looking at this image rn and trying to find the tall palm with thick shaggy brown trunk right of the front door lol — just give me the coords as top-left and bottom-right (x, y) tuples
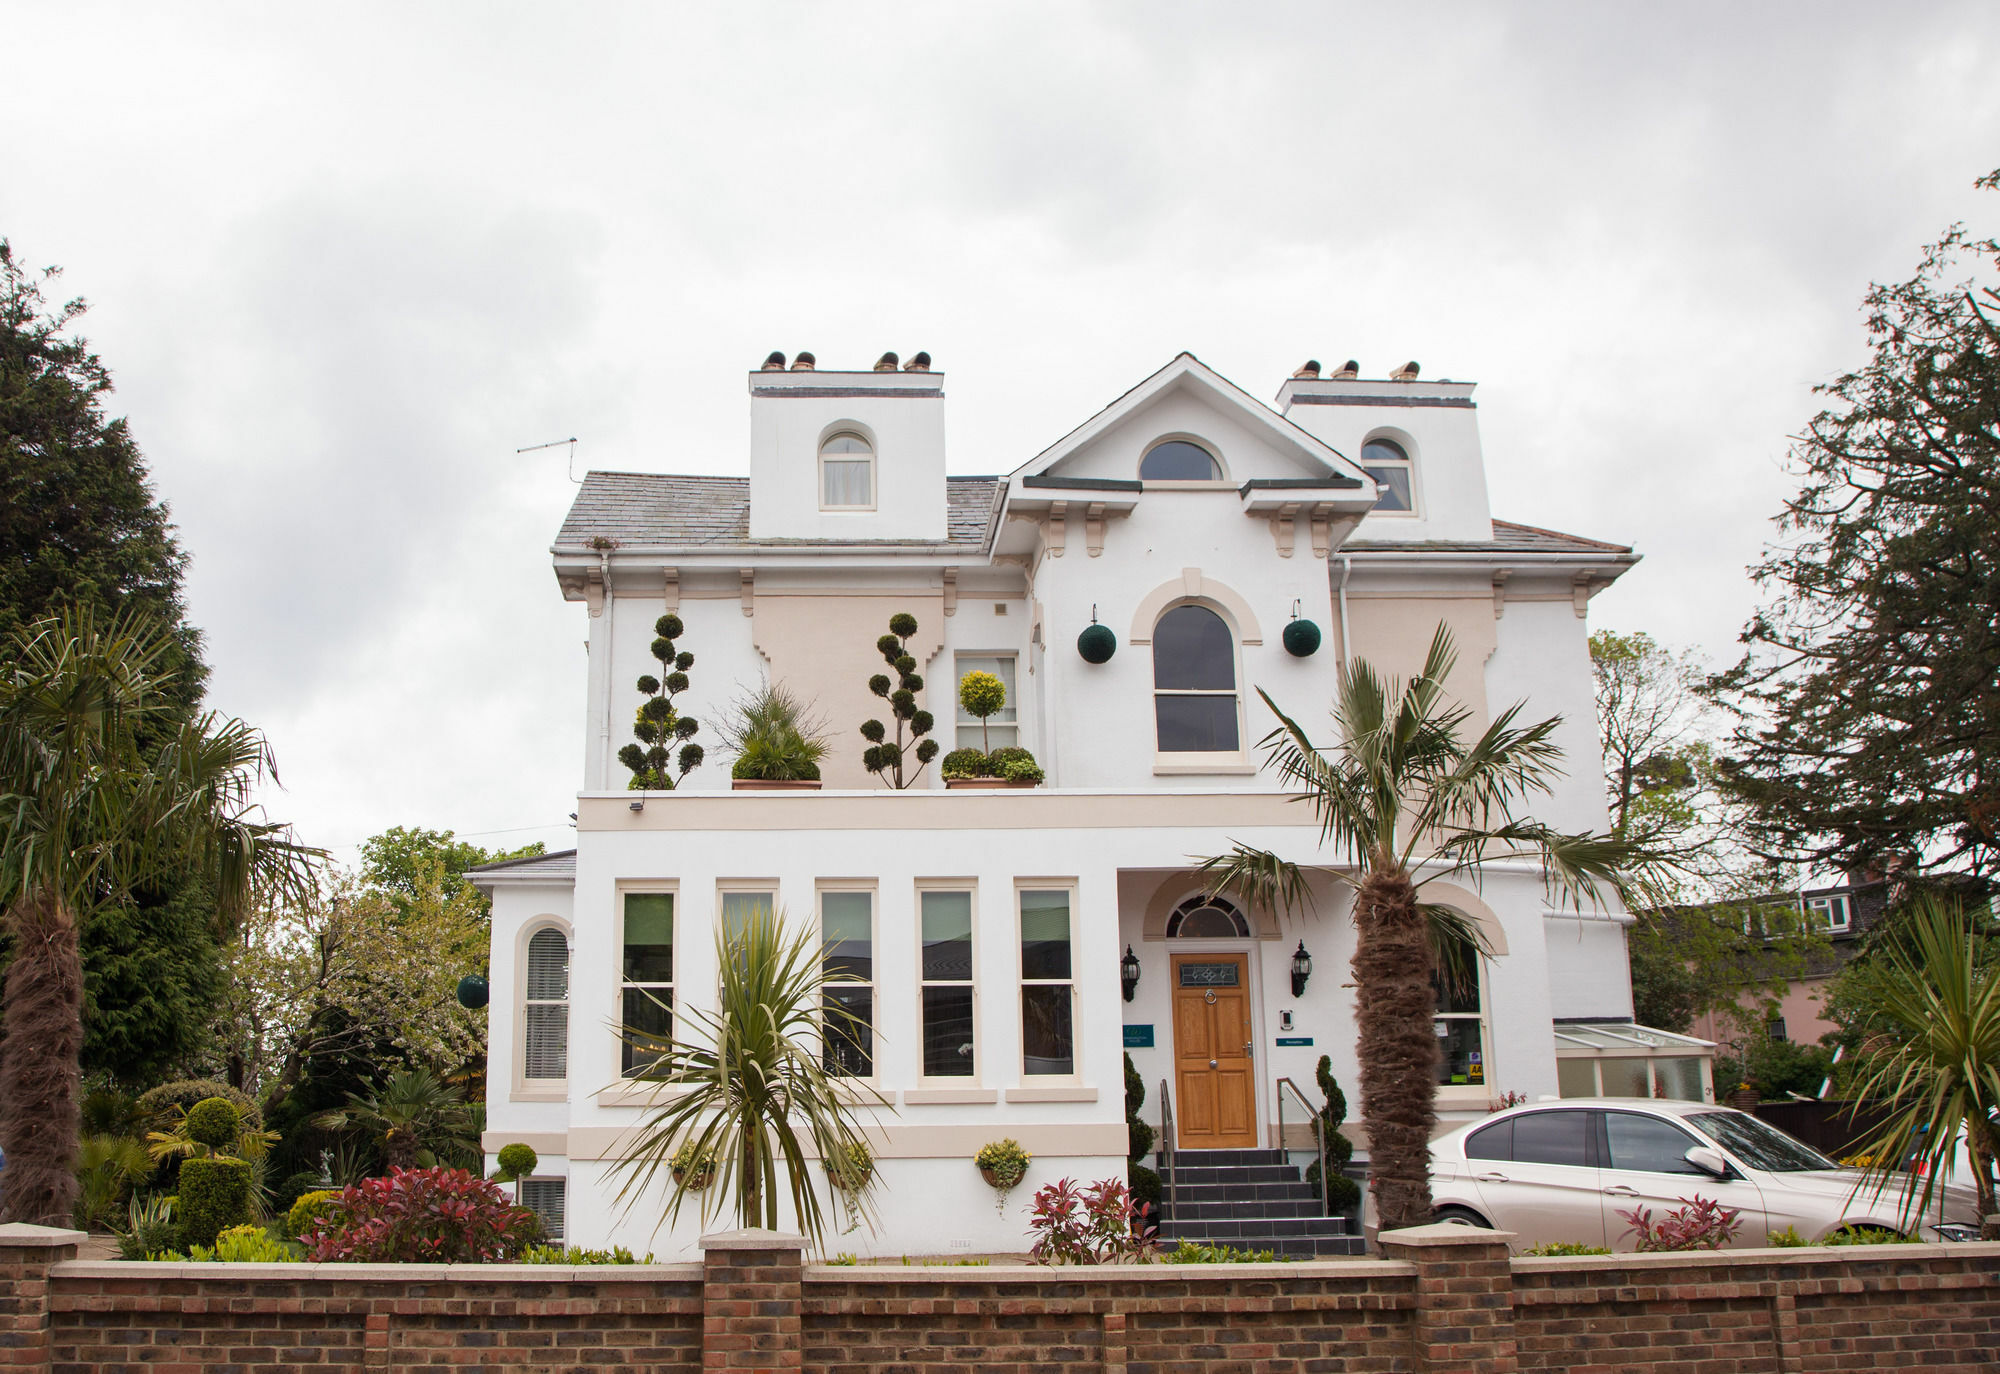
(1204, 624), (1638, 1230)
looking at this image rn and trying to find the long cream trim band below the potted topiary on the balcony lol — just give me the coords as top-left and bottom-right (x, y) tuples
(576, 788), (1318, 834)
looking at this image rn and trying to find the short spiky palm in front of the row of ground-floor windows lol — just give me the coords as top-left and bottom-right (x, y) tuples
(618, 908), (888, 1246)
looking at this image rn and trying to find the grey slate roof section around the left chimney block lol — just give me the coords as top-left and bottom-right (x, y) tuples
(556, 472), (1000, 550)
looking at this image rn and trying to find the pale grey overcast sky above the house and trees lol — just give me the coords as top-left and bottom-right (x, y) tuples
(0, 0), (2000, 854)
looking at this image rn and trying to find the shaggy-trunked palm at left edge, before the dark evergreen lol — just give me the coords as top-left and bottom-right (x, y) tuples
(0, 610), (318, 1226)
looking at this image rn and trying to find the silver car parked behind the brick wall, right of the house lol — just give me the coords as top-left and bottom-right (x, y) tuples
(1430, 1098), (1978, 1250)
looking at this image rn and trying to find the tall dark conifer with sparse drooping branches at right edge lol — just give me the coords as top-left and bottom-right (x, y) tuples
(1716, 172), (2000, 874)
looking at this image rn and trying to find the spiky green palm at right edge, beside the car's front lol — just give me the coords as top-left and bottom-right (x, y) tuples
(1854, 894), (2000, 1240)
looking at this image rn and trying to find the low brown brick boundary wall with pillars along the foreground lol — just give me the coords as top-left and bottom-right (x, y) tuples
(0, 1226), (2000, 1374)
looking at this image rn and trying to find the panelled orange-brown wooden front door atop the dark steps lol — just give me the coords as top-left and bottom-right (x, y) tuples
(1174, 954), (1256, 1150)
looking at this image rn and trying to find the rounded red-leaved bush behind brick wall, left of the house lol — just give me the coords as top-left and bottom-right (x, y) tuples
(300, 1168), (542, 1264)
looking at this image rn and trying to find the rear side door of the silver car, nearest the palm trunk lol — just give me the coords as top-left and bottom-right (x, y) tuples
(1466, 1108), (1604, 1250)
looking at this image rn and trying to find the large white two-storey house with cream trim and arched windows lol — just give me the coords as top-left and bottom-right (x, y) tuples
(476, 354), (1706, 1256)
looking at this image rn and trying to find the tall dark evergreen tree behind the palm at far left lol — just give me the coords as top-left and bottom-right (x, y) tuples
(0, 240), (220, 1086)
